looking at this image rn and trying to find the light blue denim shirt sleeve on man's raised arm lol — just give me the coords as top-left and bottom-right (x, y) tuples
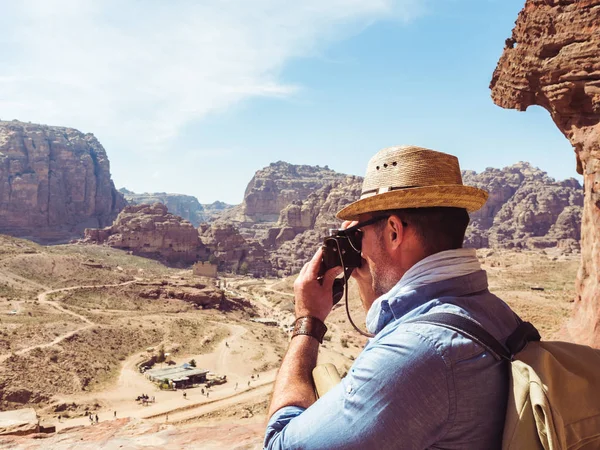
(264, 329), (456, 450)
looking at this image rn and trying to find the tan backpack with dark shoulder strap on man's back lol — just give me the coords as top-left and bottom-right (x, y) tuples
(409, 313), (600, 450)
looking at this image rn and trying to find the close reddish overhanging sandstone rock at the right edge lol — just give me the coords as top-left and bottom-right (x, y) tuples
(491, 0), (600, 347)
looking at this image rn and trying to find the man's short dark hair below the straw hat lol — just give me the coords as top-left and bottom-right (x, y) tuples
(379, 206), (470, 255)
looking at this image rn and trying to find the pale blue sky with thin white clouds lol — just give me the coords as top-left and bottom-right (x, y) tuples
(0, 0), (580, 204)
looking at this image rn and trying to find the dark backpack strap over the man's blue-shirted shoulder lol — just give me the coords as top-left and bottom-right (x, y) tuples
(405, 312), (540, 361)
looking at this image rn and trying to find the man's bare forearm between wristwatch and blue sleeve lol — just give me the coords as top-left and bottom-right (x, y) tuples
(269, 335), (319, 417)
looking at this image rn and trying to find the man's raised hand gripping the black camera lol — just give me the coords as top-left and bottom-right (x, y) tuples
(294, 248), (343, 322)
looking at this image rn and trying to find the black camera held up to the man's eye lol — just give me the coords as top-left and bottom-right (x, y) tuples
(318, 229), (362, 305)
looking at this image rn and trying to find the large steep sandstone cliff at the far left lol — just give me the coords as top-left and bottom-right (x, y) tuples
(0, 121), (125, 242)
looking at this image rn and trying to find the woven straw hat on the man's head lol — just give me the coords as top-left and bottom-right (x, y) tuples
(337, 145), (488, 220)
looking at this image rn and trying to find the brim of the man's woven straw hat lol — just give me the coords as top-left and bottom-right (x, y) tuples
(337, 185), (488, 220)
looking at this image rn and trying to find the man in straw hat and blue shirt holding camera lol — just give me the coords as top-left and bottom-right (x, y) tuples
(264, 146), (518, 449)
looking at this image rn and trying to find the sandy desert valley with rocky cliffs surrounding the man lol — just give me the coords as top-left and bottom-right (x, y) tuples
(0, 0), (600, 449)
